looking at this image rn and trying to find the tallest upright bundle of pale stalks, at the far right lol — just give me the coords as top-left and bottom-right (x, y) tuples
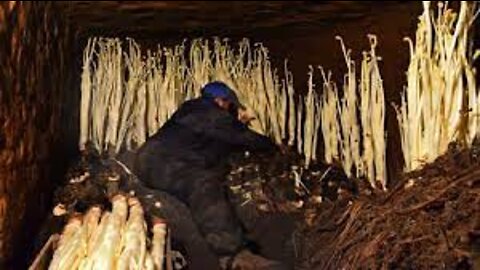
(397, 1), (480, 171)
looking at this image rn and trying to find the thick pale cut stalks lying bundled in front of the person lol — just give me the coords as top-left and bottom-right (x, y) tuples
(49, 195), (166, 270)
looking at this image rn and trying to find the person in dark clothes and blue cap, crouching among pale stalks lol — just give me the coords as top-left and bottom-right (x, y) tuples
(135, 82), (284, 268)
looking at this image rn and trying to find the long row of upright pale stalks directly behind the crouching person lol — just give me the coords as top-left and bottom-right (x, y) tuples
(79, 38), (304, 156)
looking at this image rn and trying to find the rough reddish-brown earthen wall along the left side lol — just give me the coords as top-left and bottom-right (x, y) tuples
(0, 1), (78, 268)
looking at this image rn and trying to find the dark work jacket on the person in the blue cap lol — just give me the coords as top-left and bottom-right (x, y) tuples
(135, 98), (275, 199)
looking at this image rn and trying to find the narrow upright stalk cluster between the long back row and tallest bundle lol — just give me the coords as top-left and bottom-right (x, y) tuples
(319, 35), (387, 189)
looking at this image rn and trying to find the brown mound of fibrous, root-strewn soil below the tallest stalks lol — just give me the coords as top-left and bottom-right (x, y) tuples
(297, 142), (480, 269)
